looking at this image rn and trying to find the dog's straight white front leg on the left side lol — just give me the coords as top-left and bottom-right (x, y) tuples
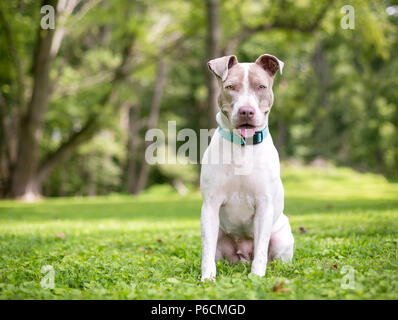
(200, 202), (220, 281)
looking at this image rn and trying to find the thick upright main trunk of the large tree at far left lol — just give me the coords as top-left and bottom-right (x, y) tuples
(7, 0), (79, 200)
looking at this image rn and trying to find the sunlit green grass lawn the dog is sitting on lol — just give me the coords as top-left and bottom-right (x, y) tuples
(0, 167), (398, 299)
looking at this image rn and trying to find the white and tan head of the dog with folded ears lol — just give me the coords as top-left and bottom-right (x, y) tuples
(208, 54), (283, 138)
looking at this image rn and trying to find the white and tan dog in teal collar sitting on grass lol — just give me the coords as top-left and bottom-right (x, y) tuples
(200, 54), (294, 281)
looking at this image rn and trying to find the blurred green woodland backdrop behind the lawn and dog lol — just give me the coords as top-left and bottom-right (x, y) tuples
(0, 0), (398, 199)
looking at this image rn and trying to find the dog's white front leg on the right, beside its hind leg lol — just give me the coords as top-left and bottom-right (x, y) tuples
(251, 195), (274, 277)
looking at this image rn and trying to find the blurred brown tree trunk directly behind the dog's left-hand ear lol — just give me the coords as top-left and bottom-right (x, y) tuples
(205, 0), (220, 129)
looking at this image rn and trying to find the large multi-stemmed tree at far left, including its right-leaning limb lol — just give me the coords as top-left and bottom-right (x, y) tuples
(1, 0), (135, 200)
